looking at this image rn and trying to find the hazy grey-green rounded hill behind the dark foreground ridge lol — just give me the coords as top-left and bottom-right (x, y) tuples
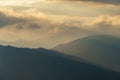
(54, 35), (120, 72)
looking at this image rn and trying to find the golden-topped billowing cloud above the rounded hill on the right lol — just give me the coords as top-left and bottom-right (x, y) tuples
(83, 15), (120, 35)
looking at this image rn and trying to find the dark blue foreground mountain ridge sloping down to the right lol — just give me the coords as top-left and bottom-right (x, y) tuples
(0, 46), (120, 80)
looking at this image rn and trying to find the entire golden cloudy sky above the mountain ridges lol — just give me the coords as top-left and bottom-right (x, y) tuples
(0, 0), (120, 48)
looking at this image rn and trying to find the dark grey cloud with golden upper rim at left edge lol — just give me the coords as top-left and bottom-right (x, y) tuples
(0, 11), (40, 30)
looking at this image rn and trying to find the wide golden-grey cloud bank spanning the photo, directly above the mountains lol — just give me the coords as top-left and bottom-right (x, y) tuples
(0, 8), (120, 48)
